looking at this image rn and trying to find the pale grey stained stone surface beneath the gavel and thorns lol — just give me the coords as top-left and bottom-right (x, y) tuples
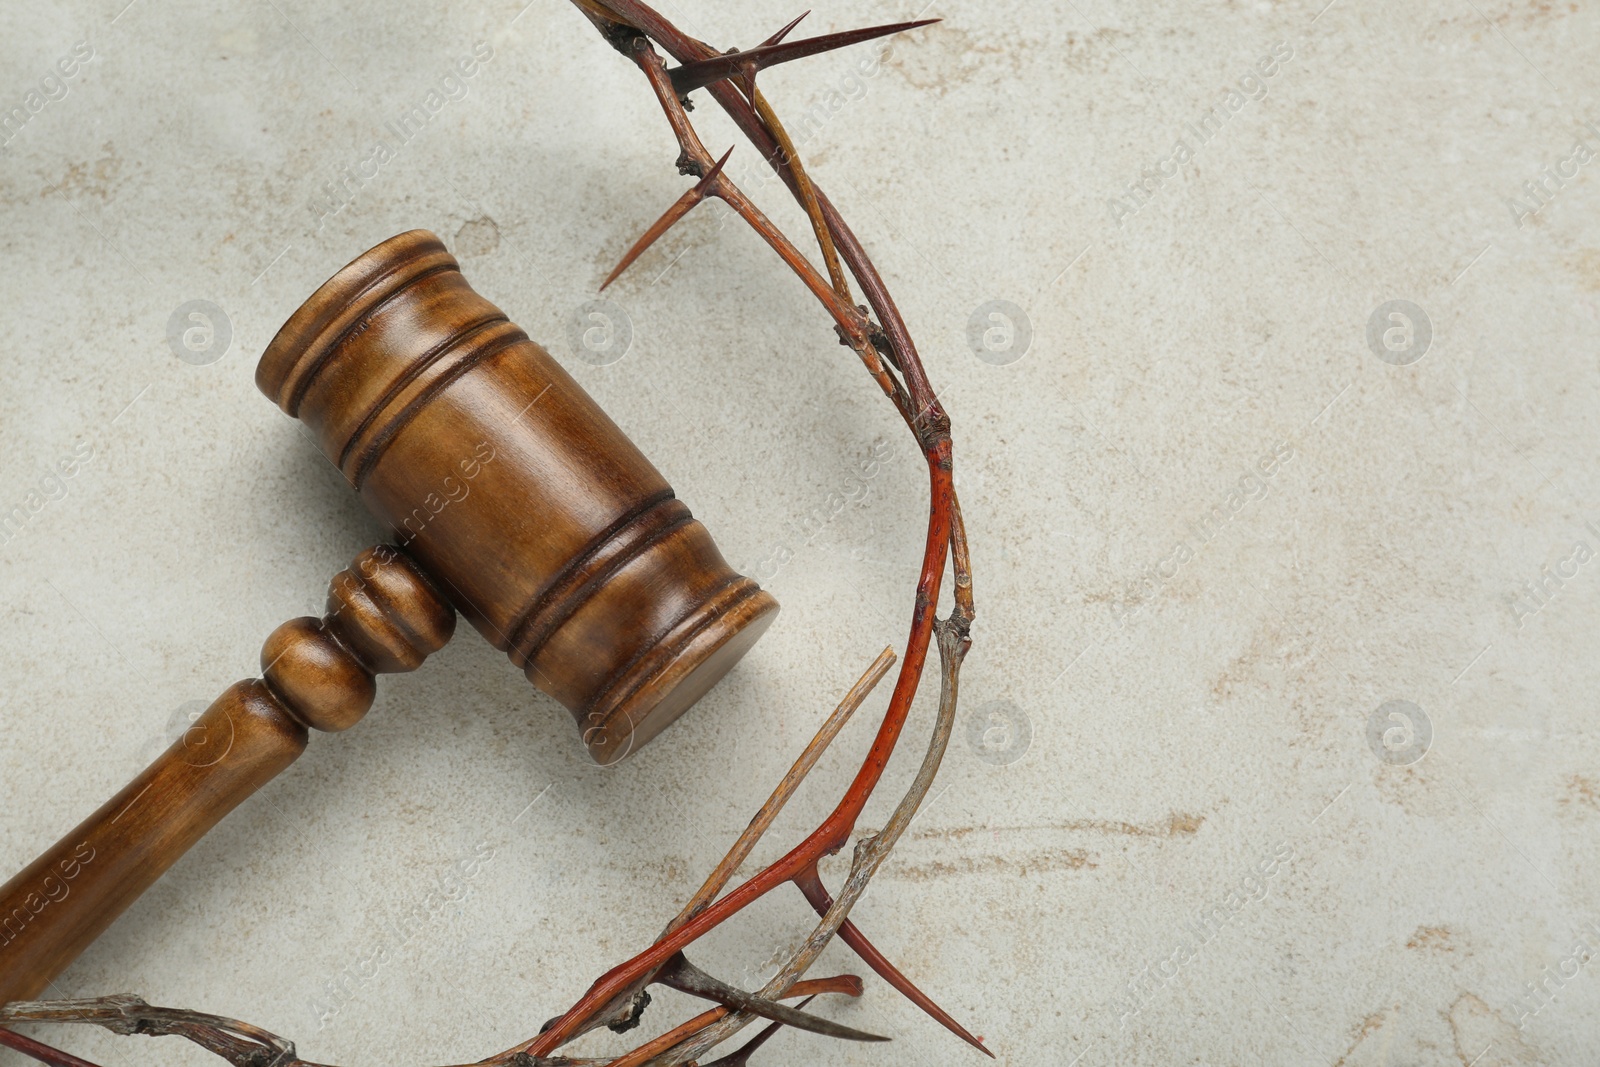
(0, 0), (1600, 1067)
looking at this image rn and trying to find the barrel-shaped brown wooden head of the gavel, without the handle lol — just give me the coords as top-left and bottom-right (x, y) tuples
(256, 230), (778, 763)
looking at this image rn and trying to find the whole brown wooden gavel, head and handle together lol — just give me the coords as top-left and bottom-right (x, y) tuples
(0, 230), (778, 1003)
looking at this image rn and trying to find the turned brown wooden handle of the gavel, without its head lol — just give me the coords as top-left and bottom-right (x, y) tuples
(0, 545), (456, 1005)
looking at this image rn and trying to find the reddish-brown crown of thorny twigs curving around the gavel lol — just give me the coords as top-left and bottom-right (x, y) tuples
(0, 0), (989, 1067)
